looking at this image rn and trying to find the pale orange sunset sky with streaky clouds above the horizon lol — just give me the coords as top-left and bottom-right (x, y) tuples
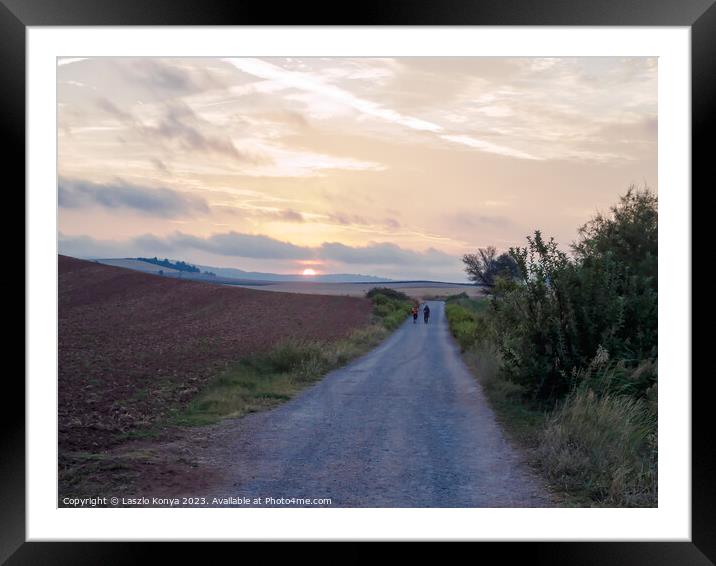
(57, 57), (658, 282)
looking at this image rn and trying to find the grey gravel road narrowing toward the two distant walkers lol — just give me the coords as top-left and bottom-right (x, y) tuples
(199, 301), (551, 507)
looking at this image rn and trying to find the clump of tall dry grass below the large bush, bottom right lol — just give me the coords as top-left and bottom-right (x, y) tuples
(538, 388), (657, 506)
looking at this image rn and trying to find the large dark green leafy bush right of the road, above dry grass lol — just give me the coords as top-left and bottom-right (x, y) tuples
(490, 188), (657, 400)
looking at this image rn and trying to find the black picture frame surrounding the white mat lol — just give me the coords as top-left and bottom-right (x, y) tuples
(7, 0), (704, 565)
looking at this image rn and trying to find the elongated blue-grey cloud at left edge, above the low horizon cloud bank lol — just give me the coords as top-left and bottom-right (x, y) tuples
(58, 178), (209, 218)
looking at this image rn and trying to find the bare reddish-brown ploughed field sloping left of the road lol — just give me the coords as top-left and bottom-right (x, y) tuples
(58, 256), (372, 456)
